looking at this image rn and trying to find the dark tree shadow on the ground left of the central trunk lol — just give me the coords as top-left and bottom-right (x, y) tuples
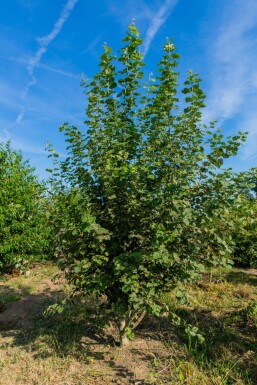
(0, 291), (103, 348)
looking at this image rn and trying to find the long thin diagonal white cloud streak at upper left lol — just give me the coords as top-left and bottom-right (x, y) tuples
(16, 0), (78, 124)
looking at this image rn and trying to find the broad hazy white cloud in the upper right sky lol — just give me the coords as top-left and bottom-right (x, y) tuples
(203, 0), (257, 120)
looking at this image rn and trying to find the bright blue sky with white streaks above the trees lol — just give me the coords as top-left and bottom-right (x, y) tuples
(0, 0), (257, 177)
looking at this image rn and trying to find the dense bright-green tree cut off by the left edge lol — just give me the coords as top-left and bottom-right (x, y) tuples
(0, 142), (49, 271)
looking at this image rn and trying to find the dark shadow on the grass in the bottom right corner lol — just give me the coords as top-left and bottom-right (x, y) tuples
(168, 309), (257, 384)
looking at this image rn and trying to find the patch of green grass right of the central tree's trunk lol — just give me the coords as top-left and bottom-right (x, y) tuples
(158, 269), (257, 385)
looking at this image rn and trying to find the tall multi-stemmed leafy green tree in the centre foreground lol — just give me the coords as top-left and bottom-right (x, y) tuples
(48, 24), (252, 344)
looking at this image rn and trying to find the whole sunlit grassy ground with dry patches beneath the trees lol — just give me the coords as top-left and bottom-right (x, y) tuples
(0, 266), (257, 385)
